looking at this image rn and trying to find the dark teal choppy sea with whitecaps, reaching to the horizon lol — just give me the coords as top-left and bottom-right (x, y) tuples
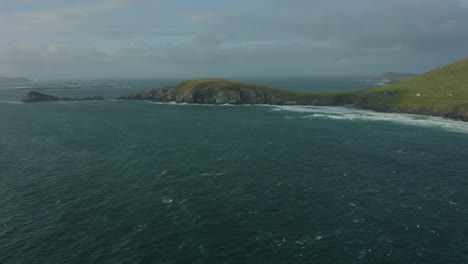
(0, 78), (468, 264)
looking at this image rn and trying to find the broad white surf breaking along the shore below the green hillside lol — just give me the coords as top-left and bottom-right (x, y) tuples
(273, 106), (468, 133)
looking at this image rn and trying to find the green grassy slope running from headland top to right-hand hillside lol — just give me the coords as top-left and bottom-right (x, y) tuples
(175, 58), (468, 112)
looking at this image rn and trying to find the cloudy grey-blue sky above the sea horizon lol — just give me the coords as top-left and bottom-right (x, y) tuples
(0, 0), (468, 80)
